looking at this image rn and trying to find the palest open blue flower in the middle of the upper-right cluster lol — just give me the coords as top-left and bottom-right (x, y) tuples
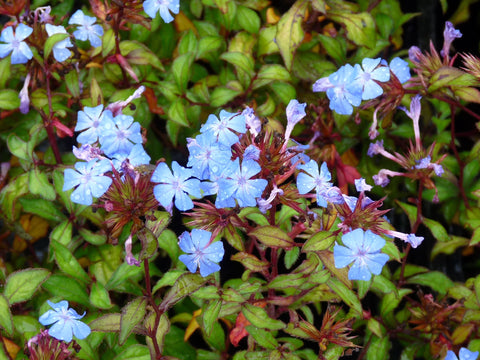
(356, 58), (390, 100)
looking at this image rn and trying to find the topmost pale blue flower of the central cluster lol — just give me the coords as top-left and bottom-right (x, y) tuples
(200, 110), (247, 146)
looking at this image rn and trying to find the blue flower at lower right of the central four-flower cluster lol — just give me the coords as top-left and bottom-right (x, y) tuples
(217, 158), (268, 207)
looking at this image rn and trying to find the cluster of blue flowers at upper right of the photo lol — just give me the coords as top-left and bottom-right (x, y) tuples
(313, 57), (410, 115)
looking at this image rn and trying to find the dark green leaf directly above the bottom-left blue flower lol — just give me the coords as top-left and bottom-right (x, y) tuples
(42, 274), (90, 306)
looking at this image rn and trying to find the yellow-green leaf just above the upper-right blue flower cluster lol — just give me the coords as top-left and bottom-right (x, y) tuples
(328, 12), (377, 48)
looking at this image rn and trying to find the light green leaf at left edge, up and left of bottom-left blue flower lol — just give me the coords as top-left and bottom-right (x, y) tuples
(3, 268), (50, 305)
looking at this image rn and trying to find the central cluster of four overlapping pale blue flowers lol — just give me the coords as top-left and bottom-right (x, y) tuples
(152, 110), (267, 211)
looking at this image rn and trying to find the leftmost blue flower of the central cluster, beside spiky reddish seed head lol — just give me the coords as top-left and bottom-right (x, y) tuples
(151, 161), (202, 211)
